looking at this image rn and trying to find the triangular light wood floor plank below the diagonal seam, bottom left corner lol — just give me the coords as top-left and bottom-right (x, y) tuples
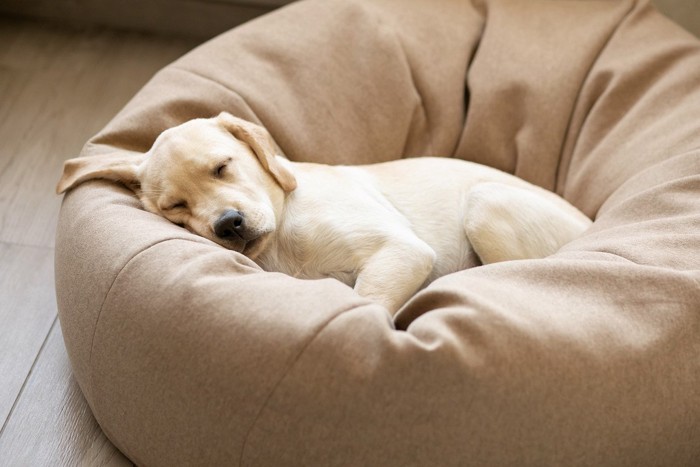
(0, 321), (132, 467)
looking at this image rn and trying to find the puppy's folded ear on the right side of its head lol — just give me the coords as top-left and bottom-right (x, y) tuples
(216, 112), (297, 193)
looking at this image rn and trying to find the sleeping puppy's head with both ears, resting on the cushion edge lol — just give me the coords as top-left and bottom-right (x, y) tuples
(56, 112), (296, 258)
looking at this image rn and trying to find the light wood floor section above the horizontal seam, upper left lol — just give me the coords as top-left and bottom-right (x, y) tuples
(0, 20), (195, 246)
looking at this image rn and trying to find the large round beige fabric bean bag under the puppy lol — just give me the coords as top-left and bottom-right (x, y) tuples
(56, 0), (700, 466)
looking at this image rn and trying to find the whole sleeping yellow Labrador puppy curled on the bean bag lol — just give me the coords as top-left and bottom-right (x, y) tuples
(57, 112), (591, 314)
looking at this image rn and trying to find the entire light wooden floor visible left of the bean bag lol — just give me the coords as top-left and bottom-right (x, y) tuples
(0, 18), (197, 467)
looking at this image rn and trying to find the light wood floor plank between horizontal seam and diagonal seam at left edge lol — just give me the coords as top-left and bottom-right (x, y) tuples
(0, 243), (56, 432)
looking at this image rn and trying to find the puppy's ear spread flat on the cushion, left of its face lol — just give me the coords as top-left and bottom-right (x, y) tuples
(56, 151), (146, 195)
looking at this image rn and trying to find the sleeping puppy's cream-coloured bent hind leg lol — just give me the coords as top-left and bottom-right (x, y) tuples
(464, 182), (591, 264)
